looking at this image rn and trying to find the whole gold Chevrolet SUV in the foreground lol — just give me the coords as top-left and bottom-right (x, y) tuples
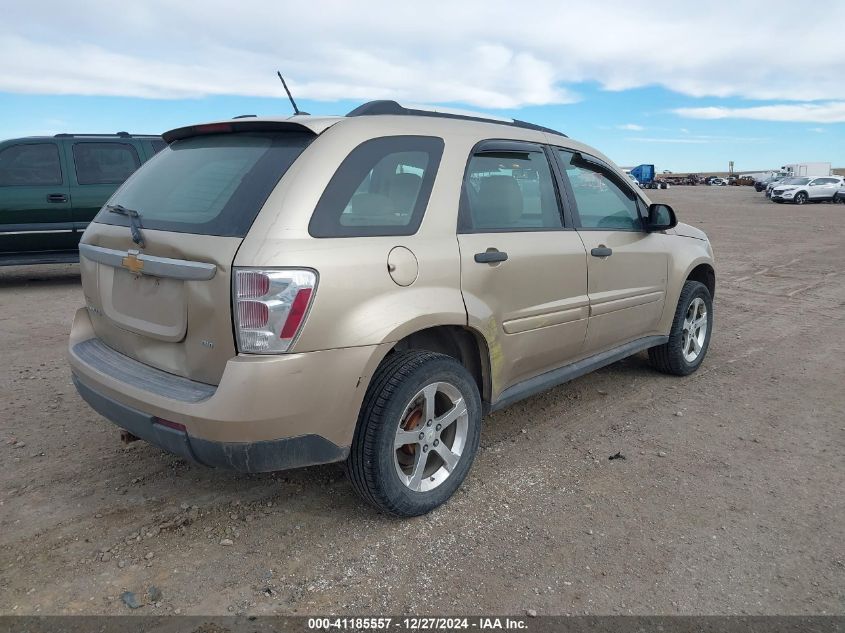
(69, 101), (715, 516)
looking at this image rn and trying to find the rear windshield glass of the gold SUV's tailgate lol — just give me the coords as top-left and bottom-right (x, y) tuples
(95, 133), (314, 237)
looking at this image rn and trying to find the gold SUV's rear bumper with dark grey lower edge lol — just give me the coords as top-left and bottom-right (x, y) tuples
(68, 308), (389, 472)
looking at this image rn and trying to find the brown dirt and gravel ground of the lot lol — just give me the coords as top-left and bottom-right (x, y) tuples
(0, 187), (845, 615)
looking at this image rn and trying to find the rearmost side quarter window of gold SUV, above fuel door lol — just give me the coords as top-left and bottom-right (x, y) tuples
(308, 136), (443, 237)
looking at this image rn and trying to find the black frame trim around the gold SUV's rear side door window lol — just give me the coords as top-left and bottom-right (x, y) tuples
(456, 138), (575, 235)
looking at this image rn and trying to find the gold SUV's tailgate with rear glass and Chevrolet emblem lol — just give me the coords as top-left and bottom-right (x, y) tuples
(80, 132), (313, 384)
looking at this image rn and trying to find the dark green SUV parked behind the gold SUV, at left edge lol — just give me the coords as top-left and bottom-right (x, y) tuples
(0, 132), (166, 266)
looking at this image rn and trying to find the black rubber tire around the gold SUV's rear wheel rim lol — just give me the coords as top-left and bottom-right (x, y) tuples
(346, 350), (481, 517)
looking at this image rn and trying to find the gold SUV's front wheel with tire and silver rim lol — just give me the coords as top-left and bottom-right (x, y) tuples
(648, 281), (713, 376)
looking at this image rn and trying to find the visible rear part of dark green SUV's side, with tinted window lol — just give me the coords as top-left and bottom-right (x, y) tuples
(65, 138), (141, 233)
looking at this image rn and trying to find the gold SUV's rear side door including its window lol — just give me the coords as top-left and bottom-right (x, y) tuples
(458, 141), (588, 400)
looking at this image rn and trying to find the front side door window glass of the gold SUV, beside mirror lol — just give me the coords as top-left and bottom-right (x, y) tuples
(558, 150), (642, 231)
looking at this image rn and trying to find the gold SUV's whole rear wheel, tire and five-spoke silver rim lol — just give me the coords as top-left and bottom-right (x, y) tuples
(346, 350), (481, 517)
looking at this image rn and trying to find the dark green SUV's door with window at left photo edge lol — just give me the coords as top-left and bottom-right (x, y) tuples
(0, 139), (75, 255)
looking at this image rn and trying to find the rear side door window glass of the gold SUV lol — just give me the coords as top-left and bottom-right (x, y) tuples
(462, 148), (563, 231)
